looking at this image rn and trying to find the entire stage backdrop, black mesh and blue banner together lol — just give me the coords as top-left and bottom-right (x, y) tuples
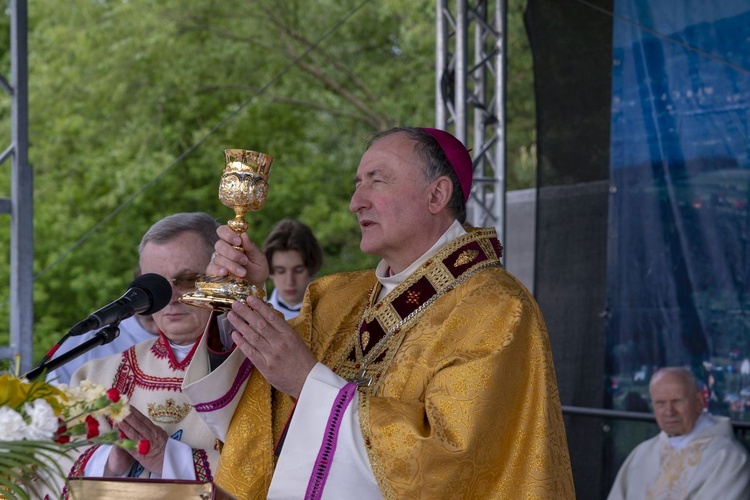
(526, 0), (750, 499)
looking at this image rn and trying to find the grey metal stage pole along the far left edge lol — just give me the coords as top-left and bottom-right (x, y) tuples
(0, 0), (34, 373)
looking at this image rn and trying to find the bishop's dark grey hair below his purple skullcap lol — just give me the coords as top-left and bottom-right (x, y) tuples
(367, 127), (466, 224)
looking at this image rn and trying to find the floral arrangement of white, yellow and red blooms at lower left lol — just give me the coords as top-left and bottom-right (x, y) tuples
(0, 374), (149, 499)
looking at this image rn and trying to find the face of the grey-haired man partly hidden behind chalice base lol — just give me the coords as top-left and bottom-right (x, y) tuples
(140, 232), (211, 345)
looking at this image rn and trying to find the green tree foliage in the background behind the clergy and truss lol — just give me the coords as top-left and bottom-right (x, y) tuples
(0, 0), (534, 356)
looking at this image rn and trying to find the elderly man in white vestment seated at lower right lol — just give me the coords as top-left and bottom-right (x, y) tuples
(608, 367), (750, 500)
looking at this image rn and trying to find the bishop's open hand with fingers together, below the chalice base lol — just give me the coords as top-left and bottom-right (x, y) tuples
(227, 296), (318, 399)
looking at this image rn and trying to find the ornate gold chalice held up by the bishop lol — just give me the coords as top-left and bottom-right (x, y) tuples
(179, 149), (273, 311)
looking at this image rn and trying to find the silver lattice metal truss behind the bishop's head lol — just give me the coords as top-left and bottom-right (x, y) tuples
(435, 0), (507, 246)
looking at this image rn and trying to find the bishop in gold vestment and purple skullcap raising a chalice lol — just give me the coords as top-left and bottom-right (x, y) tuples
(183, 128), (575, 500)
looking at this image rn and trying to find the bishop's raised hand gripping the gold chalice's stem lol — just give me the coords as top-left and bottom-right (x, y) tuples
(206, 226), (268, 289)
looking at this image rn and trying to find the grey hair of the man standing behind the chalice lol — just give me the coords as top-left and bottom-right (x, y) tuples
(138, 212), (219, 261)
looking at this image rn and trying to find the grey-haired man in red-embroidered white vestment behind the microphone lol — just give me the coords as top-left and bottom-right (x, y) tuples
(70, 213), (218, 481)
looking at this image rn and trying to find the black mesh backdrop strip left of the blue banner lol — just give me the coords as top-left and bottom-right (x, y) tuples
(526, 0), (612, 499)
